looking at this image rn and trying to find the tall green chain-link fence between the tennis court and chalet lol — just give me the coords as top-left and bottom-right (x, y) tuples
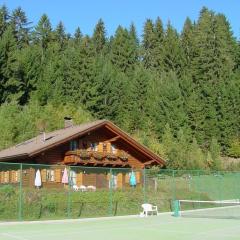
(0, 163), (240, 221)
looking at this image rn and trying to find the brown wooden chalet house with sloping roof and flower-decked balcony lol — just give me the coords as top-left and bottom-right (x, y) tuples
(0, 119), (165, 188)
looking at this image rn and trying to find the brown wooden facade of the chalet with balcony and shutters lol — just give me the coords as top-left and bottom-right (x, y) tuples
(0, 121), (164, 189)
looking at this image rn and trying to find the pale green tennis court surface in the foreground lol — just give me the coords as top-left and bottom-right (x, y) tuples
(0, 214), (240, 240)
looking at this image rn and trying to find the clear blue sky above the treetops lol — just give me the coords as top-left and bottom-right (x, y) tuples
(0, 0), (240, 38)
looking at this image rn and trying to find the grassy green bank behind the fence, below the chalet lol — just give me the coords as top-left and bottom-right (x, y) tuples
(0, 185), (208, 221)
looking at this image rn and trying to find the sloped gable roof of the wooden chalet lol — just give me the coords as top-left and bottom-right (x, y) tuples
(0, 120), (165, 165)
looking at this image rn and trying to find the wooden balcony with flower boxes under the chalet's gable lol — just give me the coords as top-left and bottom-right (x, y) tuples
(64, 149), (129, 167)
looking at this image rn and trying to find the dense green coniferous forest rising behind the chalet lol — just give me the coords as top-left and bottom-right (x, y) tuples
(0, 6), (240, 170)
